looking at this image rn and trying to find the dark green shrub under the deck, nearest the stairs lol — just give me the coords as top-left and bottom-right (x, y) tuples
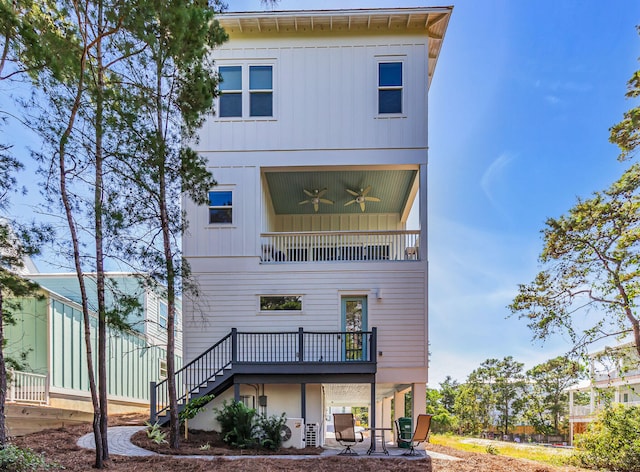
(215, 401), (258, 449)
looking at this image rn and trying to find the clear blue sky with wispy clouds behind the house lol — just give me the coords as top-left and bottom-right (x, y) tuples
(6, 0), (640, 387)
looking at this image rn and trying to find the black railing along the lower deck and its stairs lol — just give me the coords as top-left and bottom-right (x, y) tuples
(150, 328), (377, 421)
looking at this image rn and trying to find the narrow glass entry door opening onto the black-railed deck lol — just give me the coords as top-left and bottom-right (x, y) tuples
(342, 297), (367, 361)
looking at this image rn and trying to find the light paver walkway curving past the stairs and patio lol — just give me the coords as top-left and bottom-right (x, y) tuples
(78, 426), (460, 461)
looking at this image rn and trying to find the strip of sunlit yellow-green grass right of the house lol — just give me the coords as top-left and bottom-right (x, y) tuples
(429, 434), (571, 466)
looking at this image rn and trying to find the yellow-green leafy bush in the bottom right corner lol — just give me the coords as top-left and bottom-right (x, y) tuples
(572, 404), (640, 472)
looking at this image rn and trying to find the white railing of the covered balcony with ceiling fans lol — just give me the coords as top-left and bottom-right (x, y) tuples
(260, 230), (420, 263)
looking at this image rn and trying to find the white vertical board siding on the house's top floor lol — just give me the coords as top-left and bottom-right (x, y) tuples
(197, 39), (428, 153)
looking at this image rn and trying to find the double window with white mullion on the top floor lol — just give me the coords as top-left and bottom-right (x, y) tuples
(218, 64), (273, 118)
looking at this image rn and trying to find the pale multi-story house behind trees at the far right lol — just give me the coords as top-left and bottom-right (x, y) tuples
(569, 343), (640, 444)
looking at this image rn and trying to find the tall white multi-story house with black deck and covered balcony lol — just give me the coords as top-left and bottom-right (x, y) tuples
(152, 7), (452, 444)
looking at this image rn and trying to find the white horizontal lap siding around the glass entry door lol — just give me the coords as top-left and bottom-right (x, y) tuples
(185, 264), (427, 382)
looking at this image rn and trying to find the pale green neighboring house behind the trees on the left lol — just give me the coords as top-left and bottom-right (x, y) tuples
(5, 273), (182, 434)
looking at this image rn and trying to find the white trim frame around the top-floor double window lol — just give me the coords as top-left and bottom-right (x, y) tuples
(214, 59), (278, 121)
